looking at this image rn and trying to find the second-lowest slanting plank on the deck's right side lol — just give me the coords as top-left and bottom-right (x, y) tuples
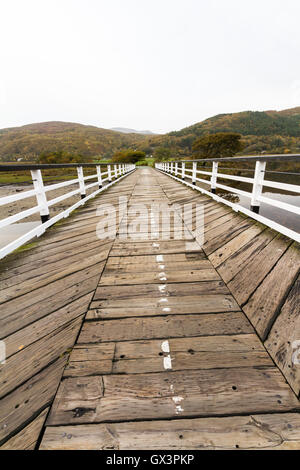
(243, 243), (300, 340)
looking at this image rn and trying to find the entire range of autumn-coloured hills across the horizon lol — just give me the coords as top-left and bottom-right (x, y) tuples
(0, 107), (300, 161)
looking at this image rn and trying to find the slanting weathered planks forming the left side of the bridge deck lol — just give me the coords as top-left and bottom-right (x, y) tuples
(0, 172), (135, 449)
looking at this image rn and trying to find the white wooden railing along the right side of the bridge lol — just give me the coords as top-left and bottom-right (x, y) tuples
(155, 154), (300, 242)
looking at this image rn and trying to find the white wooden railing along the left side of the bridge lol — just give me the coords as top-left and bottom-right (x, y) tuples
(0, 163), (135, 259)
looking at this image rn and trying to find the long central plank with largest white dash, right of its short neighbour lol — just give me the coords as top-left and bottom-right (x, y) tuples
(112, 335), (273, 374)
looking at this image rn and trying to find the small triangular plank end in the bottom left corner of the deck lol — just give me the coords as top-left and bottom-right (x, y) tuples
(0, 408), (49, 450)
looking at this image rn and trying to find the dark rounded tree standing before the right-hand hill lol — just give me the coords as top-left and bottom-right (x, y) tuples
(192, 132), (244, 158)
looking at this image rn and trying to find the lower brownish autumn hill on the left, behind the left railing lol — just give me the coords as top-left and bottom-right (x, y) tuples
(0, 121), (145, 161)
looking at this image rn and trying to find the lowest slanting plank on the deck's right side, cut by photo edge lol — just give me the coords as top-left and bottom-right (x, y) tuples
(265, 276), (300, 396)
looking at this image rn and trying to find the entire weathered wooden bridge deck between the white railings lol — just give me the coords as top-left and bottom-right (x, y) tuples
(0, 169), (300, 449)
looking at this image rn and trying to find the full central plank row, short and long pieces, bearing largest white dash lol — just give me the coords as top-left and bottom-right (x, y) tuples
(64, 334), (273, 377)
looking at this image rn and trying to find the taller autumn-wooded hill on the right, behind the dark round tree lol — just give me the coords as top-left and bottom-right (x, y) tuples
(142, 107), (300, 156)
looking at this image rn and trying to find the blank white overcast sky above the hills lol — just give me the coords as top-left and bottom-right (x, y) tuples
(0, 0), (300, 132)
